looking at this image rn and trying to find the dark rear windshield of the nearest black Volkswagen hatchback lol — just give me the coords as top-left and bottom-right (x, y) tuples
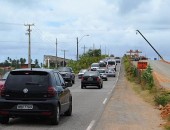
(6, 71), (49, 90)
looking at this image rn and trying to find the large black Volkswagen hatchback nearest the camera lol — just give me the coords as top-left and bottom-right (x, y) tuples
(0, 69), (72, 125)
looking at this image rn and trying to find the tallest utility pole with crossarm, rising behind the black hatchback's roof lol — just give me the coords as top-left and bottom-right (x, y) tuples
(25, 24), (34, 68)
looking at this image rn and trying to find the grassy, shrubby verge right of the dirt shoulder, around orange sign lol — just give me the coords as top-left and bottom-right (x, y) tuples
(124, 56), (170, 130)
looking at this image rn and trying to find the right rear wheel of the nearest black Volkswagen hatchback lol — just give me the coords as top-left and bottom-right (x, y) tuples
(51, 105), (60, 125)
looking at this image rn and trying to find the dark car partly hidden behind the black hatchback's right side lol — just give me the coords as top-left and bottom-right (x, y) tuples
(58, 67), (75, 85)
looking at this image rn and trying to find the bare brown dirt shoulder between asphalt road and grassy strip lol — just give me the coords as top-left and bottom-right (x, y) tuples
(95, 65), (163, 130)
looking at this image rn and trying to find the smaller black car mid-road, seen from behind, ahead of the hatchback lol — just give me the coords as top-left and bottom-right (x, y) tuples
(81, 71), (103, 89)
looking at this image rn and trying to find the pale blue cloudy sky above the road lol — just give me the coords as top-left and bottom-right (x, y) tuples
(0, 0), (170, 63)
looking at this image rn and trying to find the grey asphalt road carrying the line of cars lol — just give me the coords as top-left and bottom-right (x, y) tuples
(0, 64), (120, 130)
